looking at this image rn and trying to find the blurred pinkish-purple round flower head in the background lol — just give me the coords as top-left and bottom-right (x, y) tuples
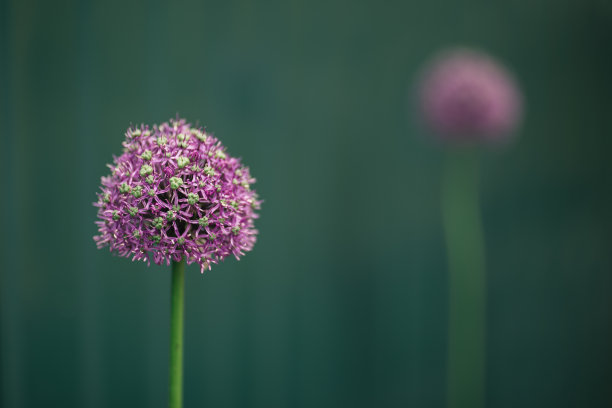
(420, 49), (521, 141)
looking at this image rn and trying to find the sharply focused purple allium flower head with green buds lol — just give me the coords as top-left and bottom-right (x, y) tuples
(94, 119), (260, 272)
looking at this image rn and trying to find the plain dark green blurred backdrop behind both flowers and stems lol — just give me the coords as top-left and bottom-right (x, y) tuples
(0, 0), (612, 408)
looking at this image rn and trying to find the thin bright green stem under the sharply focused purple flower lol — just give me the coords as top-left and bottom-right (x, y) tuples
(170, 258), (185, 408)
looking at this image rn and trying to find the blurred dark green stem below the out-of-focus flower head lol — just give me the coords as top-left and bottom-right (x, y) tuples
(442, 148), (486, 408)
